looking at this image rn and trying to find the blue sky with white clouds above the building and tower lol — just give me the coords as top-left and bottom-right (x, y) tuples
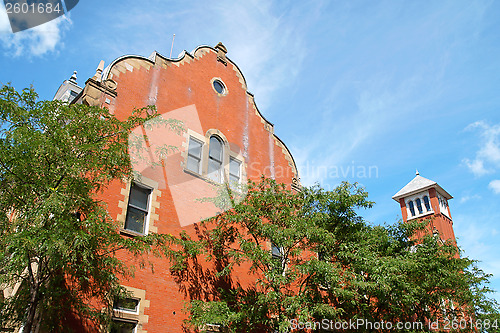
(0, 0), (500, 300)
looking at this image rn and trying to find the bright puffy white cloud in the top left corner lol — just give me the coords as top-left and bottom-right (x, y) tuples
(0, 8), (71, 58)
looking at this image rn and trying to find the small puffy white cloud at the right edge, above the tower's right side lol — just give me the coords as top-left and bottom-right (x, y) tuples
(463, 121), (500, 176)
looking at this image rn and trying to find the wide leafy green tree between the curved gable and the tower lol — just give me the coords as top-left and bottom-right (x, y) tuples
(171, 178), (498, 332)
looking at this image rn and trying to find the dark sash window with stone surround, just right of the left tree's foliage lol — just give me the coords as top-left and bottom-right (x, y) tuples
(125, 183), (151, 234)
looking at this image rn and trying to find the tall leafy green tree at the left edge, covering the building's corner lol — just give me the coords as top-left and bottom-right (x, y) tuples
(0, 86), (176, 332)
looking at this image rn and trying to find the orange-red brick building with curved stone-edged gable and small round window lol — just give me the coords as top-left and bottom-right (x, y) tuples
(68, 43), (298, 333)
